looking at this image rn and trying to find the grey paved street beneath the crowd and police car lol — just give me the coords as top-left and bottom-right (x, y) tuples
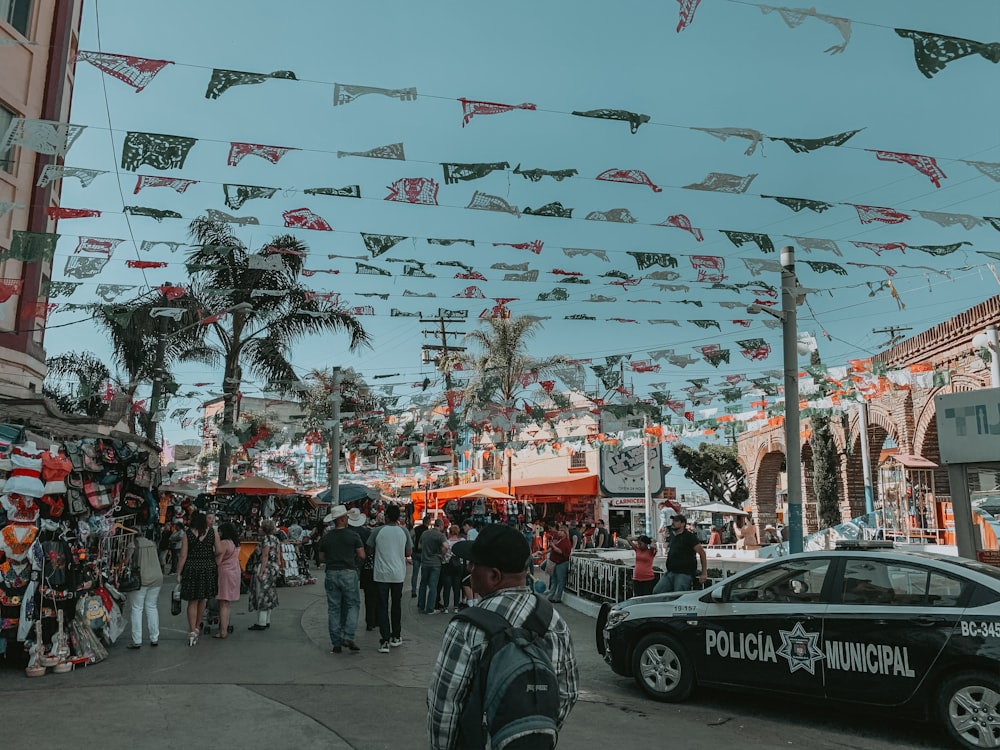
(0, 579), (942, 750)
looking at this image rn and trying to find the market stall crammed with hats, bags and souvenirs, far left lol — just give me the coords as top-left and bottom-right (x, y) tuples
(0, 430), (159, 677)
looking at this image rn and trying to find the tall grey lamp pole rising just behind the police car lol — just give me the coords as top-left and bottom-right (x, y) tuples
(747, 245), (802, 552)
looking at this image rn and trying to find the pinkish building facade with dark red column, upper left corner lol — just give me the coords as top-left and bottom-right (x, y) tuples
(0, 0), (83, 398)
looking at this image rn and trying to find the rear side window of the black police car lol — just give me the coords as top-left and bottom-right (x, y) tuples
(842, 559), (968, 607)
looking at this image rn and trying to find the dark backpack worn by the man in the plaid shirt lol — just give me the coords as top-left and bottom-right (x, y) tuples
(453, 595), (559, 750)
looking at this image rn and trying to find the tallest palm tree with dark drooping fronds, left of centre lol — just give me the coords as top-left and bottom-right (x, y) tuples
(188, 217), (370, 484)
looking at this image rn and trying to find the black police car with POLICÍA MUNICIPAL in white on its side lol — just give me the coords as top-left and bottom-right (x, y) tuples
(597, 549), (1000, 748)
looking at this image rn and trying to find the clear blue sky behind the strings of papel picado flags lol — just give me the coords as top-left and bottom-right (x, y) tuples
(39, 0), (1000, 464)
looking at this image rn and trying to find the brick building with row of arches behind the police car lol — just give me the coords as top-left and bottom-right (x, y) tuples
(737, 295), (1000, 534)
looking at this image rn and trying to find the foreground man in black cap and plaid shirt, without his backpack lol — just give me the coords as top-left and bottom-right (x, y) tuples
(427, 524), (579, 750)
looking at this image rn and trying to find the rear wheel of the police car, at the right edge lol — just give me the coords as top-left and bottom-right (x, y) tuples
(937, 671), (1000, 748)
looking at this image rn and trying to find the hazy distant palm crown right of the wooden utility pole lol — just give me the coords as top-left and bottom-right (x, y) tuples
(443, 317), (569, 437)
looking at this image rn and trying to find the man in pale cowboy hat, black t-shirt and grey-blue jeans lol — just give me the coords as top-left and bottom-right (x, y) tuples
(319, 505), (365, 654)
